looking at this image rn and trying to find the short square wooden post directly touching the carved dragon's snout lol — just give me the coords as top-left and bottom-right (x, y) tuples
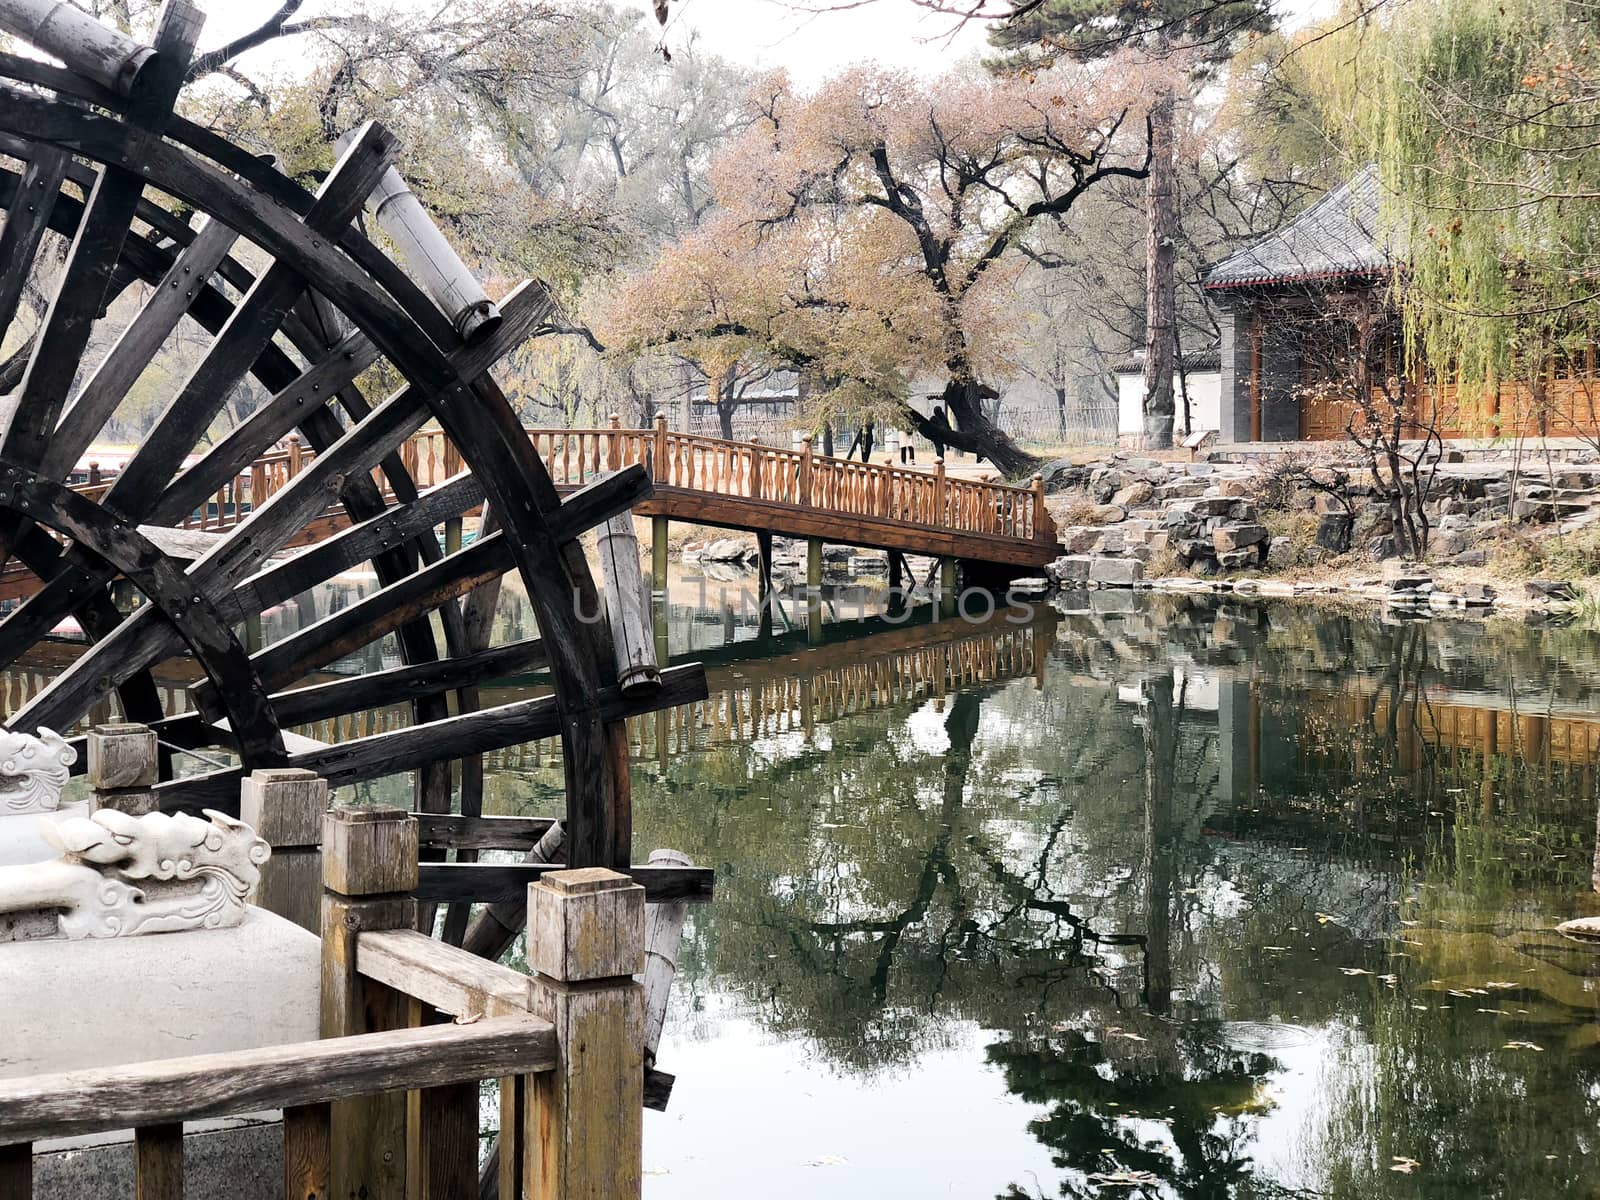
(238, 768), (328, 933)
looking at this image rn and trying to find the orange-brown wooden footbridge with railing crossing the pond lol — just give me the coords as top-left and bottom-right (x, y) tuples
(0, 418), (1061, 600)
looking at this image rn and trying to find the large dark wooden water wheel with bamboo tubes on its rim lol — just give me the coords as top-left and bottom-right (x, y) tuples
(0, 0), (704, 902)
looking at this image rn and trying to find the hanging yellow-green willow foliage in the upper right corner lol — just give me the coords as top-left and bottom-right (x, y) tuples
(1362, 0), (1600, 412)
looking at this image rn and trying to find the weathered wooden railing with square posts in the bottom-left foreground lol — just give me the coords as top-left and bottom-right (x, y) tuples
(0, 810), (645, 1200)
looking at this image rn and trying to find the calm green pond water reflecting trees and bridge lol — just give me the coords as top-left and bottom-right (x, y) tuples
(12, 579), (1600, 1200)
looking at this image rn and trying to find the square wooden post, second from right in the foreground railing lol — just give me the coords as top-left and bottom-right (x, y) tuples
(322, 808), (418, 1200)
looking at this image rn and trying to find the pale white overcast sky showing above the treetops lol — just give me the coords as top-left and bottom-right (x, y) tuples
(202, 0), (1336, 83)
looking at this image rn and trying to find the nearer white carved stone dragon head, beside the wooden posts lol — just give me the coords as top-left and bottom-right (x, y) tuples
(0, 810), (272, 939)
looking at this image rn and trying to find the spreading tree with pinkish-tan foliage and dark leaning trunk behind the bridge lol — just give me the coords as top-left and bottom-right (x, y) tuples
(604, 61), (1173, 474)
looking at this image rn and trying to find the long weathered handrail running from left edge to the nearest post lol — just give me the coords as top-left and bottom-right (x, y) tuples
(0, 1016), (557, 1144)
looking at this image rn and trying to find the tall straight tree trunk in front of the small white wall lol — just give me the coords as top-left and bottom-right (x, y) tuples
(1144, 90), (1178, 450)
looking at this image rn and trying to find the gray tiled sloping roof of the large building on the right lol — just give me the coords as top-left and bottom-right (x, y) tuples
(1205, 166), (1390, 288)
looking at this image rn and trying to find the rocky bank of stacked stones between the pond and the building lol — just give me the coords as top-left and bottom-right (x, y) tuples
(1040, 446), (1600, 614)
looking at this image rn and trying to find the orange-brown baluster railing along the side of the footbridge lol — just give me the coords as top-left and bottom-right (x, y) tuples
(62, 416), (1056, 542)
